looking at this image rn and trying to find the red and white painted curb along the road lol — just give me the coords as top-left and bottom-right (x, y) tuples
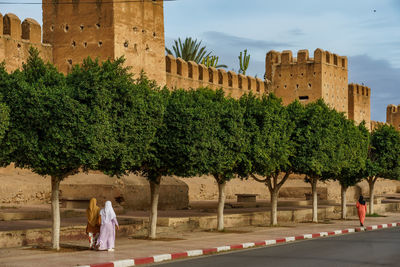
(77, 222), (400, 267)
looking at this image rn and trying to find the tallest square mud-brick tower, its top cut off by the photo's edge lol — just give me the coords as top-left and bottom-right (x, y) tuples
(42, 0), (166, 85)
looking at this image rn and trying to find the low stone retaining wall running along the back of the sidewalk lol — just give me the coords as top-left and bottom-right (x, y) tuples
(0, 203), (400, 248)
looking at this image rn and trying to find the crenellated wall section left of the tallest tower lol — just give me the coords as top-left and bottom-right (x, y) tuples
(0, 13), (53, 71)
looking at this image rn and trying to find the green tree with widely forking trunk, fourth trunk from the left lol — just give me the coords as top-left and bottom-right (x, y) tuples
(240, 94), (294, 225)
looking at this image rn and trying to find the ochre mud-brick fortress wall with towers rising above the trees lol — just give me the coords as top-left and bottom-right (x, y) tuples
(0, 0), (399, 131)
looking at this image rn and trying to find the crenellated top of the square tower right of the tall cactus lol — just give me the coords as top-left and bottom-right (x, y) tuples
(265, 48), (348, 69)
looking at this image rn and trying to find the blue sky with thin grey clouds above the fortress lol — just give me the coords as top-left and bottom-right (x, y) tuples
(0, 0), (400, 121)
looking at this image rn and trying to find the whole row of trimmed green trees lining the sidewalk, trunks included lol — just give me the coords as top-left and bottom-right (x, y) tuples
(0, 50), (400, 249)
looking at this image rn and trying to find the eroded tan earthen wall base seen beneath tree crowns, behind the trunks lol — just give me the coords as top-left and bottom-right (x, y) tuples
(0, 166), (400, 209)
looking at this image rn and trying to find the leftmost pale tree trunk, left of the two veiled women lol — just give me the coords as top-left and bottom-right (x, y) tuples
(51, 176), (60, 250)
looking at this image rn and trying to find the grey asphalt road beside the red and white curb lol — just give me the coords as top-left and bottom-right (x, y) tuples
(155, 227), (400, 267)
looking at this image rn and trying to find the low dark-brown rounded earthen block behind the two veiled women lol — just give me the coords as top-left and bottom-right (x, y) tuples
(60, 173), (189, 210)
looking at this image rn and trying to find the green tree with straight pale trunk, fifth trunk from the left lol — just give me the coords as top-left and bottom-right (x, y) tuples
(292, 99), (344, 222)
